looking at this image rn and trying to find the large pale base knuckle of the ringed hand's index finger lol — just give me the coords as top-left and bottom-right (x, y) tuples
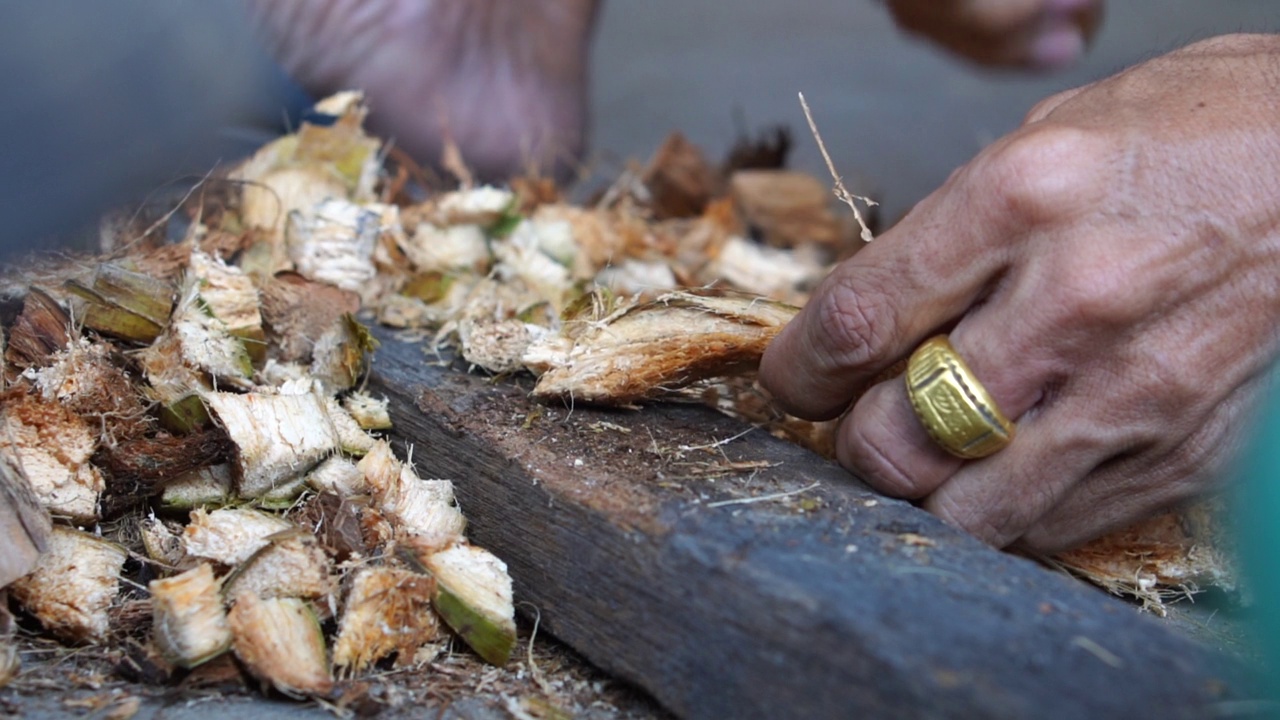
(978, 123), (1103, 225)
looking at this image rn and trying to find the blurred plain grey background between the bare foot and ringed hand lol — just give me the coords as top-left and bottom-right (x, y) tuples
(593, 0), (1280, 218)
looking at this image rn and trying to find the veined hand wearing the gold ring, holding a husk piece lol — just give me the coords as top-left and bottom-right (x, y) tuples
(760, 36), (1280, 551)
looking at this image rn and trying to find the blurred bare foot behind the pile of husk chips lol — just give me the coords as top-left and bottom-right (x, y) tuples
(247, 0), (598, 179)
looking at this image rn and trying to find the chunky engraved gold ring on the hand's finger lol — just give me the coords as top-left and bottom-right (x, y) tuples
(906, 334), (1014, 459)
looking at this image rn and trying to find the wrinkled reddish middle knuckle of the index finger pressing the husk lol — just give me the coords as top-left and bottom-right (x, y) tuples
(813, 269), (897, 370)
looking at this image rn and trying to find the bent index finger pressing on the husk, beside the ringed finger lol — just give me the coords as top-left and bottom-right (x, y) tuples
(759, 169), (1011, 419)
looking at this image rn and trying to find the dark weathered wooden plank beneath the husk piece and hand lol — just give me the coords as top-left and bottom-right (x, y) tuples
(371, 331), (1248, 719)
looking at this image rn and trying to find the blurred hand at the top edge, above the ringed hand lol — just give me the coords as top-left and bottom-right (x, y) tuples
(888, 0), (1102, 69)
